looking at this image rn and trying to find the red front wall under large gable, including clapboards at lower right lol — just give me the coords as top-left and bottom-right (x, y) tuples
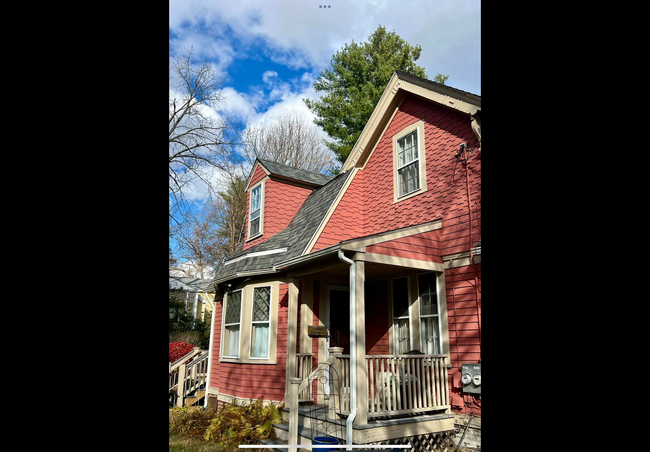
(313, 96), (481, 415)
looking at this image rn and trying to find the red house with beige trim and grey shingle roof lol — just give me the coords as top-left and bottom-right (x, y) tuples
(206, 71), (481, 443)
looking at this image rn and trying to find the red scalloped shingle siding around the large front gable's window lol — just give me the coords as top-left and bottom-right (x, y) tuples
(313, 96), (481, 260)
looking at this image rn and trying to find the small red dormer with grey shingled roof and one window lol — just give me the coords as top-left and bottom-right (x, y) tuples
(243, 158), (332, 250)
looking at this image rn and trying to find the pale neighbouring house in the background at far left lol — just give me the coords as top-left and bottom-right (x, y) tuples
(169, 276), (215, 321)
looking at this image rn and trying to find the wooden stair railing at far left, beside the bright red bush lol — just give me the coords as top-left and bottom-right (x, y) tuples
(169, 347), (208, 407)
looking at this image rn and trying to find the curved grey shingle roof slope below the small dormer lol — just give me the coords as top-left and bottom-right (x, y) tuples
(215, 173), (351, 283)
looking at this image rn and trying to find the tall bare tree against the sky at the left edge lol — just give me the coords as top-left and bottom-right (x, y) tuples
(169, 48), (238, 225)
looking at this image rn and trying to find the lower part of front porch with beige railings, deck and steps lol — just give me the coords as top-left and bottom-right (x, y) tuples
(282, 347), (454, 450)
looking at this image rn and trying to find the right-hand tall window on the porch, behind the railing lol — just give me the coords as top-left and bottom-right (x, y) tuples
(418, 273), (442, 355)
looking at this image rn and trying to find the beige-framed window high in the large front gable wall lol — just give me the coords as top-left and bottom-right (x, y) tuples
(393, 121), (427, 202)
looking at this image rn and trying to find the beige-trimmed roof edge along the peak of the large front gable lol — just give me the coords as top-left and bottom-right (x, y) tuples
(341, 71), (481, 172)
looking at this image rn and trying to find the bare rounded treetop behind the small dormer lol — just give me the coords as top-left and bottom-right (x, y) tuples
(243, 113), (334, 173)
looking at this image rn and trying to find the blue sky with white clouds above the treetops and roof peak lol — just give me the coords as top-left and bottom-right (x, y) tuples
(169, 0), (481, 198)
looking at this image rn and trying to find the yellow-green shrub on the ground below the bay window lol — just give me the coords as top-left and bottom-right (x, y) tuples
(203, 397), (284, 448)
